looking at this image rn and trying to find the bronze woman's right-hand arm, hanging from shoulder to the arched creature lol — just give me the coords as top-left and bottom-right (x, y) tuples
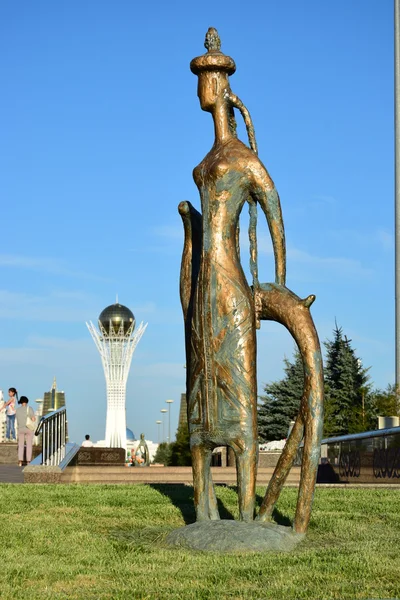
(250, 163), (286, 285)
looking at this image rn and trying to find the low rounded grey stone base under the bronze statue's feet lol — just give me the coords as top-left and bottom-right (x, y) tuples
(166, 520), (304, 553)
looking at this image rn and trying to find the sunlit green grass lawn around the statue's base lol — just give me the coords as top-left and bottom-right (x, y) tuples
(0, 484), (400, 600)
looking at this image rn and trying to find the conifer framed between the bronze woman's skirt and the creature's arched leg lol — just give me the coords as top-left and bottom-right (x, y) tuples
(258, 349), (304, 442)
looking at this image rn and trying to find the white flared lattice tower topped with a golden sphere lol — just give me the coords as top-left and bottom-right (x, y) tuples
(86, 301), (147, 448)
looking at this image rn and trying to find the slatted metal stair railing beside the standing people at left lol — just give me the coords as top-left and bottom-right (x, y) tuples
(35, 407), (67, 467)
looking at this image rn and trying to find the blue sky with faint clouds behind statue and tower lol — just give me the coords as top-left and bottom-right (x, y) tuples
(0, 0), (394, 441)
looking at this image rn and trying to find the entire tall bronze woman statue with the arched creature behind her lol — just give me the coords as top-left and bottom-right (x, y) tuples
(179, 28), (323, 532)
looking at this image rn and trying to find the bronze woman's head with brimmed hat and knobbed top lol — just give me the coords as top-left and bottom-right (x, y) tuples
(190, 27), (236, 112)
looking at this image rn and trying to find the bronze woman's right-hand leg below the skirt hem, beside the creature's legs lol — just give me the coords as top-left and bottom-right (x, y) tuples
(233, 441), (258, 521)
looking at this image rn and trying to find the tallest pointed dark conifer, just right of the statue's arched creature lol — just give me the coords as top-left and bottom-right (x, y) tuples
(324, 324), (372, 436)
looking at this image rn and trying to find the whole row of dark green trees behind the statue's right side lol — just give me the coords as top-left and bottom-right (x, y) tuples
(258, 324), (400, 442)
